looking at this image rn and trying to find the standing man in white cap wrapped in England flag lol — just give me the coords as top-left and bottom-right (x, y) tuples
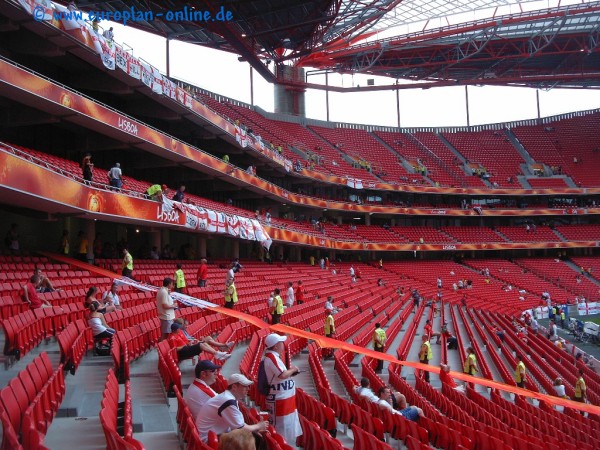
(264, 333), (302, 446)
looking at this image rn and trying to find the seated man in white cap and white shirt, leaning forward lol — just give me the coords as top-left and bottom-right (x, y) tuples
(196, 373), (269, 442)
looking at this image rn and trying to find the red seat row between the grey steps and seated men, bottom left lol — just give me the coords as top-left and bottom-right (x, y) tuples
(100, 369), (145, 450)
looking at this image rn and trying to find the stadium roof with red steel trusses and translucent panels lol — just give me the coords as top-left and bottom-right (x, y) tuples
(78, 0), (600, 91)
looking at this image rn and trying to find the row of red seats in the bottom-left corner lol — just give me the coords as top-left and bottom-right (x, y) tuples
(0, 352), (65, 450)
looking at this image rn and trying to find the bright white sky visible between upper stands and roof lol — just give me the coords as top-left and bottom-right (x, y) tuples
(110, 24), (600, 127)
